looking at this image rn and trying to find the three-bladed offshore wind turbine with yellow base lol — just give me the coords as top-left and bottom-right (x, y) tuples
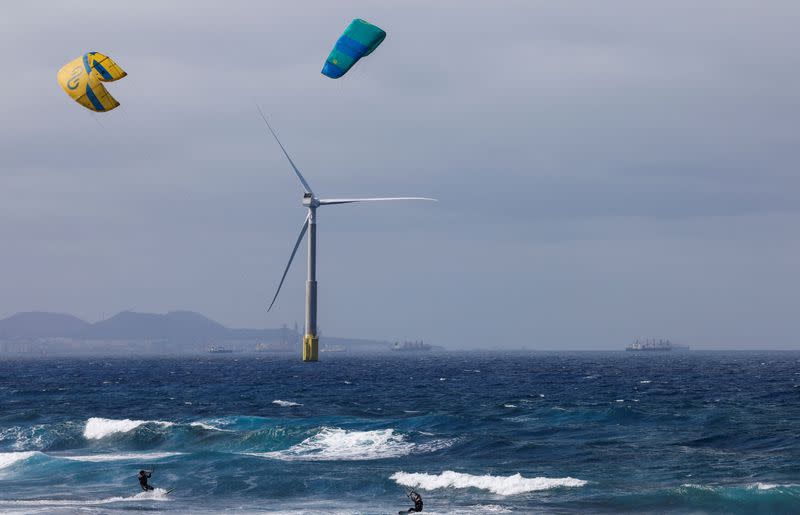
(257, 106), (436, 361)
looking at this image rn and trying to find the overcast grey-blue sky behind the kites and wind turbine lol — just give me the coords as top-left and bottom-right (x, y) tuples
(0, 0), (800, 349)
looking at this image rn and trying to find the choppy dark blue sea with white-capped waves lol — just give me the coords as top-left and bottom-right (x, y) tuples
(0, 352), (800, 513)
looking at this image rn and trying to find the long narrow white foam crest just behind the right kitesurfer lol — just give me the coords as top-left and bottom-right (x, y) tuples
(390, 470), (586, 495)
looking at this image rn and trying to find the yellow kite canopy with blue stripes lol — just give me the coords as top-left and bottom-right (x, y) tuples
(57, 52), (127, 112)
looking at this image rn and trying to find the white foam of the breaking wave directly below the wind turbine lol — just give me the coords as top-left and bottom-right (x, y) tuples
(248, 427), (452, 461)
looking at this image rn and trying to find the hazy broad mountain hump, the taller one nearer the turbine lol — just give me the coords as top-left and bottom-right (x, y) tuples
(76, 311), (229, 342)
